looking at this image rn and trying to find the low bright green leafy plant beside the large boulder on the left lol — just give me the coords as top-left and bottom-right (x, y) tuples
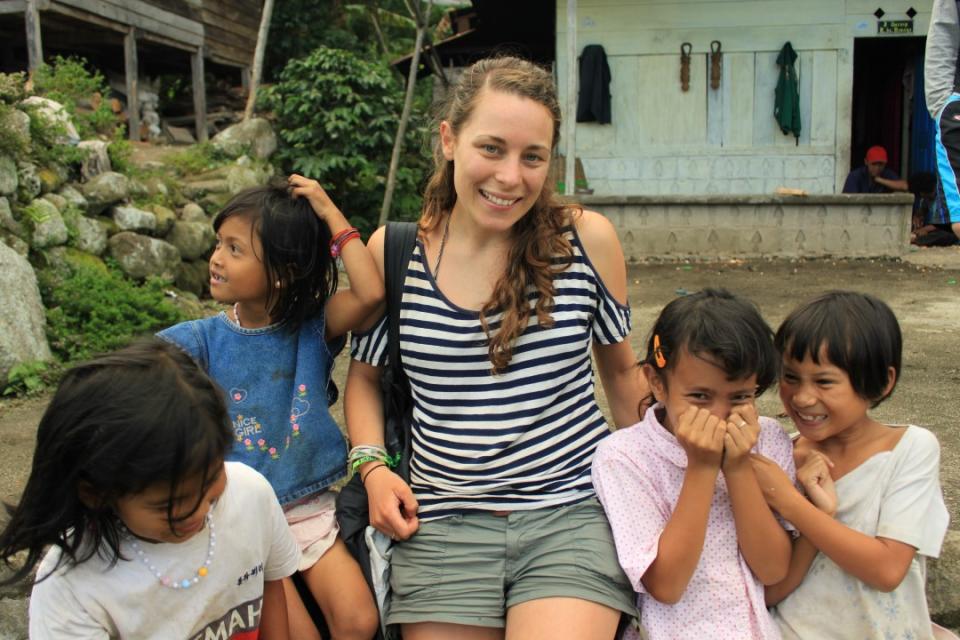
(40, 264), (184, 362)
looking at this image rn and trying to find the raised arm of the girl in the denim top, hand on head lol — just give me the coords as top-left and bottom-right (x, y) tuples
(290, 174), (384, 340)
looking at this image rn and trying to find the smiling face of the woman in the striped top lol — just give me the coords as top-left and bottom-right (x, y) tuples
(440, 89), (554, 231)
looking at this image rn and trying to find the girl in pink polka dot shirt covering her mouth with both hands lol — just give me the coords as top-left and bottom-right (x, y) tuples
(593, 289), (795, 640)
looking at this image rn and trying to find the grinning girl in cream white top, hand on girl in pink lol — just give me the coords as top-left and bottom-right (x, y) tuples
(754, 291), (949, 640)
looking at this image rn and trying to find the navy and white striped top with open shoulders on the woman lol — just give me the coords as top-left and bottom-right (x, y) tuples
(353, 229), (630, 520)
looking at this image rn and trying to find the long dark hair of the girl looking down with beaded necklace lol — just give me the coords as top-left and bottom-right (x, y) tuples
(0, 338), (233, 583)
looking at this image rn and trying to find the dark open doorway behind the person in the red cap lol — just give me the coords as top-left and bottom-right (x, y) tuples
(850, 36), (933, 177)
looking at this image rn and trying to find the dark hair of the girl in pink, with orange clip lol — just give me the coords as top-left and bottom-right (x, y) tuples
(641, 289), (779, 395)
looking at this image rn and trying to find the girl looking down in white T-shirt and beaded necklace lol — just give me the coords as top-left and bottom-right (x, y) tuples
(0, 340), (299, 640)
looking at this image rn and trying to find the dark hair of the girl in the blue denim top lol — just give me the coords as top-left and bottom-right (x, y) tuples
(213, 183), (338, 331)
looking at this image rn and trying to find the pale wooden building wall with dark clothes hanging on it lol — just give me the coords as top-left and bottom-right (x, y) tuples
(556, 0), (932, 197)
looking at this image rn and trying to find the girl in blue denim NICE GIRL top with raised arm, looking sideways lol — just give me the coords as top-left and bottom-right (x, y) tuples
(159, 175), (384, 639)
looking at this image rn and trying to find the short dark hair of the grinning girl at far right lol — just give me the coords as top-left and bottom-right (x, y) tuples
(775, 291), (903, 407)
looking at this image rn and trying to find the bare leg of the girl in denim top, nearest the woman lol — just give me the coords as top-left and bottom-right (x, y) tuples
(306, 537), (380, 640)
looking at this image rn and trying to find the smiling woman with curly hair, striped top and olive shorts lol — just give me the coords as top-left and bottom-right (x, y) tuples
(345, 57), (646, 640)
